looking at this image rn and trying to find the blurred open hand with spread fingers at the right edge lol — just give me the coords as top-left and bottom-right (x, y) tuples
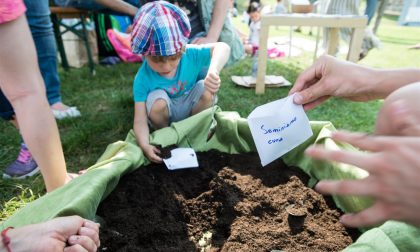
(306, 132), (420, 227)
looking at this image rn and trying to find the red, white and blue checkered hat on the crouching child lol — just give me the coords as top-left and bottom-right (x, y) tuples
(131, 1), (191, 56)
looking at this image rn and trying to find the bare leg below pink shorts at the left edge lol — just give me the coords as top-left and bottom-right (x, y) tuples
(0, 16), (67, 192)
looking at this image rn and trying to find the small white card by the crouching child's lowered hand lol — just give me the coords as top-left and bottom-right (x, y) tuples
(163, 148), (198, 170)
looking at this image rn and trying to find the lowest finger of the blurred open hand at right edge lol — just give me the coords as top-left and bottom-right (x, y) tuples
(340, 203), (388, 227)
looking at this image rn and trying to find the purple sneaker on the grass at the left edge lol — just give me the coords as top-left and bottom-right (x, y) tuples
(3, 144), (39, 179)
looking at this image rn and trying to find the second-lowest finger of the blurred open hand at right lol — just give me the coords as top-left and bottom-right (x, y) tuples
(315, 178), (377, 196)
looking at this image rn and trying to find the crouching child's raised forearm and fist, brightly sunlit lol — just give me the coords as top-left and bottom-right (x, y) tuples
(204, 42), (230, 94)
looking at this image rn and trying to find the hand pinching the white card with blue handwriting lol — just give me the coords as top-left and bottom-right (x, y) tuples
(289, 55), (374, 110)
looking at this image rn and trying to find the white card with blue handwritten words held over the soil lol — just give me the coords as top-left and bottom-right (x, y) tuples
(248, 95), (313, 166)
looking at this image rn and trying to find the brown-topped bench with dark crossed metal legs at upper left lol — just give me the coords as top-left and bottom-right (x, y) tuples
(50, 6), (95, 75)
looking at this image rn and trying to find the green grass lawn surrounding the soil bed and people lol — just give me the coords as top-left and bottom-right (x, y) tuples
(0, 6), (420, 221)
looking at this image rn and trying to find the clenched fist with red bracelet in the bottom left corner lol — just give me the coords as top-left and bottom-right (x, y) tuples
(7, 216), (100, 252)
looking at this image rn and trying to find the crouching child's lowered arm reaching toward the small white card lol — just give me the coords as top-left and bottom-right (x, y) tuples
(133, 102), (162, 163)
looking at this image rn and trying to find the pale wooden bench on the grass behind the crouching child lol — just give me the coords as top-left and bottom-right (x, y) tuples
(255, 14), (367, 94)
